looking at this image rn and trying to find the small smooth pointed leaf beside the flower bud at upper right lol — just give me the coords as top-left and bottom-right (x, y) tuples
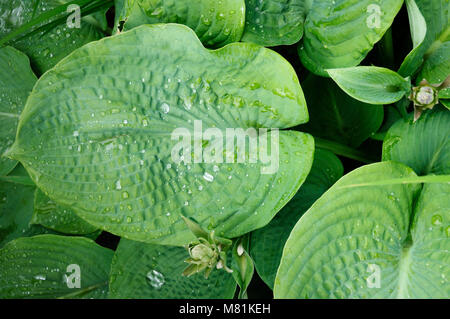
(328, 66), (411, 104)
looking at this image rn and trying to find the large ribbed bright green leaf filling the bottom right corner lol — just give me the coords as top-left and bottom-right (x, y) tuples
(274, 162), (450, 298)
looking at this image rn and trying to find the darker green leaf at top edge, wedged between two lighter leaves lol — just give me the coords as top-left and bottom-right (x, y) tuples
(242, 0), (306, 46)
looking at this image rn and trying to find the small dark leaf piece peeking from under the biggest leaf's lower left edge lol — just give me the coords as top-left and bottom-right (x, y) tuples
(31, 189), (97, 235)
